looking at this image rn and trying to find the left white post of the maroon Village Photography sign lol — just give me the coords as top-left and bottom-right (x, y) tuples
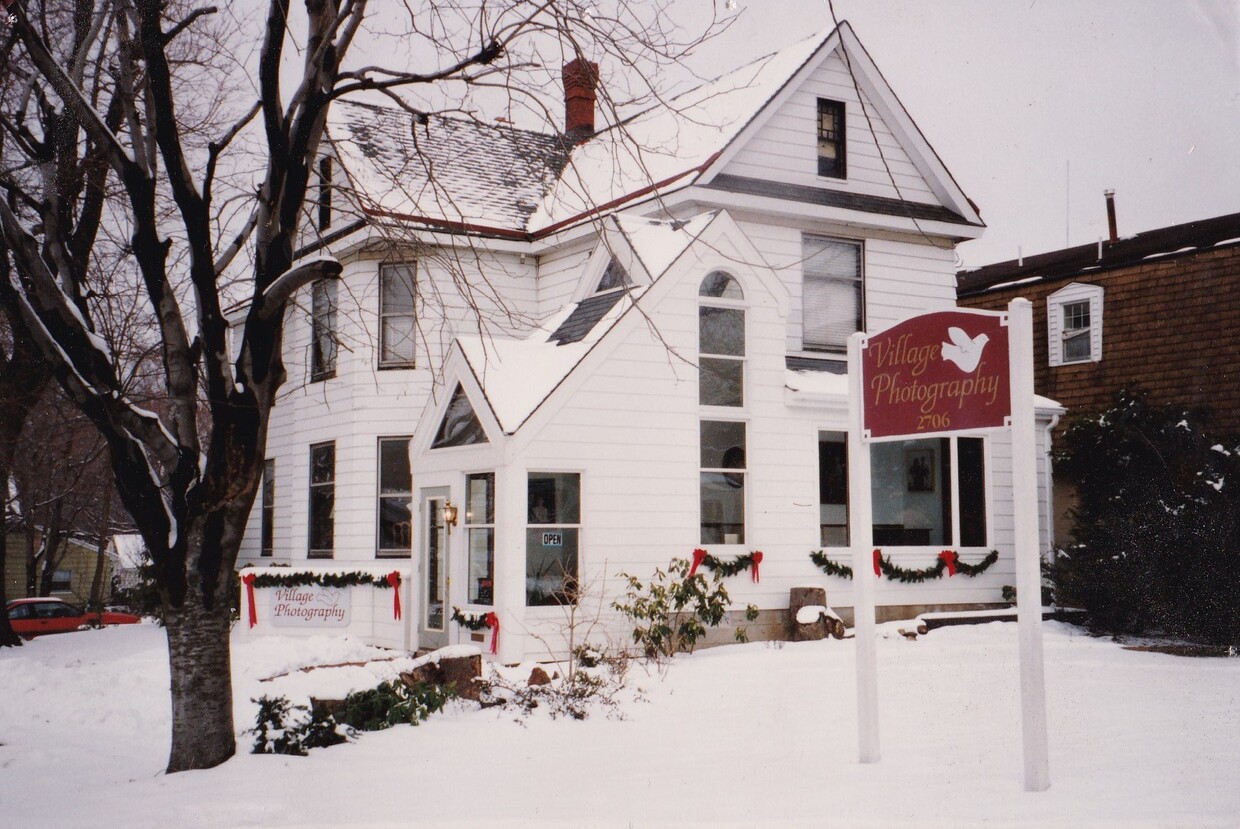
(848, 332), (882, 763)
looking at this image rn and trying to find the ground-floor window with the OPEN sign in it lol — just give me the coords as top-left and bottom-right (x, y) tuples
(526, 472), (582, 607)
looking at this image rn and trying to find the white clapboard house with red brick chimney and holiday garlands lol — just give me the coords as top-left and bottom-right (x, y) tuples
(242, 24), (1061, 662)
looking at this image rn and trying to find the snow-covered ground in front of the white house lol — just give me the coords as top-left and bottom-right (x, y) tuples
(0, 622), (1240, 828)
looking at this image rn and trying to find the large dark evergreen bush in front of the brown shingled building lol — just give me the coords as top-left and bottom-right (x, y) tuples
(1054, 390), (1240, 644)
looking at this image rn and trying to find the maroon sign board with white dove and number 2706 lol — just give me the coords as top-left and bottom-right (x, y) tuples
(861, 311), (1012, 440)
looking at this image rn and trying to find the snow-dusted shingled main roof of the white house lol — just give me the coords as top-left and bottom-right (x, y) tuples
(327, 24), (967, 238)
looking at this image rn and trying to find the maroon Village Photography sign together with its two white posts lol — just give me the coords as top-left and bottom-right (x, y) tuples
(848, 299), (1050, 792)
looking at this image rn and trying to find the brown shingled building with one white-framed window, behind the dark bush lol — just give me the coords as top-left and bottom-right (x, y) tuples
(956, 205), (1240, 542)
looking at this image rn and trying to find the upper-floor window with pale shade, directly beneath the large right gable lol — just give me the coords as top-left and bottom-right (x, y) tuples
(801, 235), (864, 351)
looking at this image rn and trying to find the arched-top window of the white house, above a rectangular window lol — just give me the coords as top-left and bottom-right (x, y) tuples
(698, 271), (745, 406)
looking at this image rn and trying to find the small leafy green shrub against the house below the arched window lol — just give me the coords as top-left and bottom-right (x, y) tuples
(611, 559), (732, 659)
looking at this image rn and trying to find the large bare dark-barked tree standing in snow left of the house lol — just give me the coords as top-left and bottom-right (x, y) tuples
(0, 0), (724, 772)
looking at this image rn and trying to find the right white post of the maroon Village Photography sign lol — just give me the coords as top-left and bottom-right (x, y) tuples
(1008, 299), (1050, 792)
